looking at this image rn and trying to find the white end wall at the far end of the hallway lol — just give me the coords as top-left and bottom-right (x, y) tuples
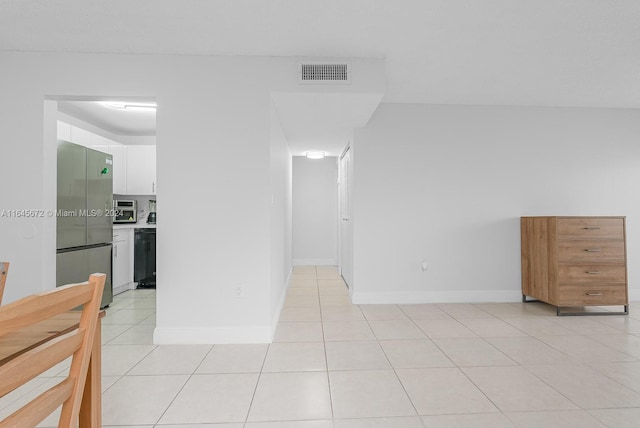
(293, 156), (338, 266)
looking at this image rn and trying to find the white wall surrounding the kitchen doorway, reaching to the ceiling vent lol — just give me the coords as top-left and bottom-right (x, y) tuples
(0, 52), (384, 343)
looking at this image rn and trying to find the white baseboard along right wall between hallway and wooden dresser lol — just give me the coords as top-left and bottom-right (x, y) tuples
(351, 290), (522, 305)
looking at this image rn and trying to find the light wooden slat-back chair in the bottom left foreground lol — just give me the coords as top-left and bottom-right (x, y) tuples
(0, 274), (106, 428)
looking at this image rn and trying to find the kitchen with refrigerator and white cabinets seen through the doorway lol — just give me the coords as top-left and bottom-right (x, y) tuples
(56, 100), (157, 307)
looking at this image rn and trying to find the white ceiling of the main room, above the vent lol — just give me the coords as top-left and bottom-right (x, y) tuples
(0, 0), (640, 151)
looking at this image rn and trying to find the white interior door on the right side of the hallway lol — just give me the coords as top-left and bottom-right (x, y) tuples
(338, 148), (353, 287)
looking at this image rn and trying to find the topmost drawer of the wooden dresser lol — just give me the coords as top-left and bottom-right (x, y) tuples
(558, 217), (624, 240)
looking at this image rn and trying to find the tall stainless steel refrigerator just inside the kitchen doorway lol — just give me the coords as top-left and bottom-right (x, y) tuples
(56, 140), (113, 307)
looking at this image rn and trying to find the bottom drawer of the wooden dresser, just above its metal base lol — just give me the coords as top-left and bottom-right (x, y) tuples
(558, 284), (628, 306)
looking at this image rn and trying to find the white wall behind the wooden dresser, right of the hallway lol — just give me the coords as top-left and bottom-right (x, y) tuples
(352, 104), (640, 303)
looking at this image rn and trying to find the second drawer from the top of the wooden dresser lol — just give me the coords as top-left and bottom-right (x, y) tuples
(558, 239), (624, 263)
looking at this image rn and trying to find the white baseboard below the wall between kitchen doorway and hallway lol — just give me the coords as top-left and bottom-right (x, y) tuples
(153, 326), (272, 345)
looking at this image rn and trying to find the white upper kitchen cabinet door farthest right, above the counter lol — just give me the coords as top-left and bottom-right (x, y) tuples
(127, 146), (156, 195)
